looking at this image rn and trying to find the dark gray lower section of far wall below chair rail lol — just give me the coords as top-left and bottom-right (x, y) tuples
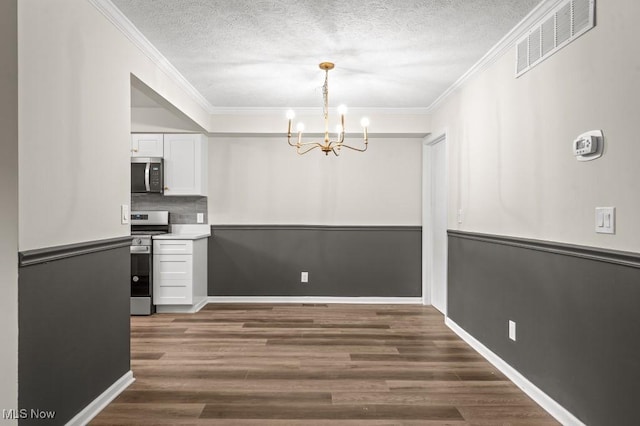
(208, 225), (422, 297)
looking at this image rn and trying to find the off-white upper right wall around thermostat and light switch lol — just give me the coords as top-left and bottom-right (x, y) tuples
(433, 0), (640, 252)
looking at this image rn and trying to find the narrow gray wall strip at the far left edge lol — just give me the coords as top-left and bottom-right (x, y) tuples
(0, 0), (18, 424)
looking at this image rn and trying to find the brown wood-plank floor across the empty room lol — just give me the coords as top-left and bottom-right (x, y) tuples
(91, 304), (558, 426)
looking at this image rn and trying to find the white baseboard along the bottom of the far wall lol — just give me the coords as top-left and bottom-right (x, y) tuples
(207, 296), (422, 305)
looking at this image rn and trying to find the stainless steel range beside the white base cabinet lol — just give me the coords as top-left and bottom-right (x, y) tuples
(131, 211), (169, 315)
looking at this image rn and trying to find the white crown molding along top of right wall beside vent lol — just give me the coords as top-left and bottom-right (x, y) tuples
(426, 0), (564, 113)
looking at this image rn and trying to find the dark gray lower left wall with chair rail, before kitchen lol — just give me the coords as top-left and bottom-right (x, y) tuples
(18, 237), (131, 425)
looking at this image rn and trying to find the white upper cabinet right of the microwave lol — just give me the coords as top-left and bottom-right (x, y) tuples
(164, 134), (208, 196)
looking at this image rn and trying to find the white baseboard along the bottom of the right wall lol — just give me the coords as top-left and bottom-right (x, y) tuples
(444, 317), (585, 426)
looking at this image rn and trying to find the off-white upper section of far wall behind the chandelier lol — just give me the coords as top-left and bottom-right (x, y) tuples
(208, 137), (422, 226)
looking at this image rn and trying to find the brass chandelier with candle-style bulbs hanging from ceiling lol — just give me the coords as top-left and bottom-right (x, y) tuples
(287, 62), (369, 156)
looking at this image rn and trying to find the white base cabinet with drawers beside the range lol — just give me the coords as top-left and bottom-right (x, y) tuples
(153, 238), (208, 313)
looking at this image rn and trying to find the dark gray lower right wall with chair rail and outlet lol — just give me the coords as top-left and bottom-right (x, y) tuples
(448, 231), (640, 425)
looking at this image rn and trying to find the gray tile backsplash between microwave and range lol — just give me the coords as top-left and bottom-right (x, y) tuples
(131, 194), (207, 224)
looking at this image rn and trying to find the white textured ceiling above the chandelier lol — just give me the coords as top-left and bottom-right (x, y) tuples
(112, 0), (539, 108)
